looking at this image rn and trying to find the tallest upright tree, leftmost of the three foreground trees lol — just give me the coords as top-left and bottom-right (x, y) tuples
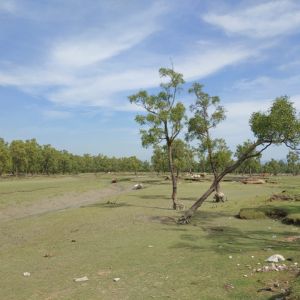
(129, 68), (185, 209)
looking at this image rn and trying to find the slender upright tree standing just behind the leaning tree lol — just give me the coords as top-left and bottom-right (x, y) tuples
(187, 82), (231, 202)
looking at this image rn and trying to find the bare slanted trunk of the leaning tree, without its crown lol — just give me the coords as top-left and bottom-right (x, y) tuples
(177, 140), (264, 224)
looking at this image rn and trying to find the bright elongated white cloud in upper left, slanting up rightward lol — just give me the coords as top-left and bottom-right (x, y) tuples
(50, 12), (161, 68)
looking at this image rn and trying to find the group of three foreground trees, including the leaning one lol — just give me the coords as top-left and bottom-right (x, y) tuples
(129, 68), (300, 224)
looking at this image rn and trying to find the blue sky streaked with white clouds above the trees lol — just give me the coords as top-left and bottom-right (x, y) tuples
(0, 0), (300, 160)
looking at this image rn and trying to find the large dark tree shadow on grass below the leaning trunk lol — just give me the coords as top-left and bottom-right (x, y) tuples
(166, 211), (300, 254)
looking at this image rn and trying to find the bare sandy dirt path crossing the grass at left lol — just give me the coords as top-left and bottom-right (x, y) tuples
(0, 184), (131, 222)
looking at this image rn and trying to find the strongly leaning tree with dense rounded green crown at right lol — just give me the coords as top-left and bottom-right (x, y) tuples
(178, 96), (300, 224)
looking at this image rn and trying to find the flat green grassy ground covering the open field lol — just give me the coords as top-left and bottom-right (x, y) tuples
(0, 175), (300, 300)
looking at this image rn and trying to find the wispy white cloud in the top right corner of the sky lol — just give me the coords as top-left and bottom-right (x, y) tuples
(202, 0), (300, 38)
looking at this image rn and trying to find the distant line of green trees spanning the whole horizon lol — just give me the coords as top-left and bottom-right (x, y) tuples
(0, 138), (300, 176)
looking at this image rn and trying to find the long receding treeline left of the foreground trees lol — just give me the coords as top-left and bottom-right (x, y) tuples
(0, 138), (150, 176)
